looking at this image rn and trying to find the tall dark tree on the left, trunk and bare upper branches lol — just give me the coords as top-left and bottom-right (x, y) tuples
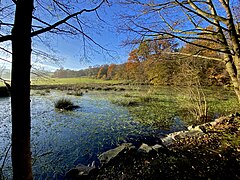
(0, 0), (105, 180)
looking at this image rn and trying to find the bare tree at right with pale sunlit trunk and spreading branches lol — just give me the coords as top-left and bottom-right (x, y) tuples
(121, 0), (240, 102)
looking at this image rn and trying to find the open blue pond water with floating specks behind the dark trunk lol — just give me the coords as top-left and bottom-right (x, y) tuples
(0, 91), (186, 179)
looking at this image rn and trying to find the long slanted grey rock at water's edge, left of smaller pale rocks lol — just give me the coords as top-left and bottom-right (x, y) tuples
(98, 143), (135, 166)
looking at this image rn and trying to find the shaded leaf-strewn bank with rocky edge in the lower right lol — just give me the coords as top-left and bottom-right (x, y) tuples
(67, 113), (240, 179)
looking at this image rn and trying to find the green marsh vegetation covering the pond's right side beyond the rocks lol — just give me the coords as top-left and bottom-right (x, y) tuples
(107, 87), (240, 130)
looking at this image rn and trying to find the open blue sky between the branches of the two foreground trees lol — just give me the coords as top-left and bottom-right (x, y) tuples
(0, 1), (131, 70)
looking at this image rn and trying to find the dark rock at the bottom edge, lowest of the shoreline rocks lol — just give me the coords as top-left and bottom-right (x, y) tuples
(65, 164), (98, 180)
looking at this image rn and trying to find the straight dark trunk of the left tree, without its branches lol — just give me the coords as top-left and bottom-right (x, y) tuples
(11, 0), (33, 180)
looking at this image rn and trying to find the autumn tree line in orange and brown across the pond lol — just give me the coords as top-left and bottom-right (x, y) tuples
(53, 39), (230, 86)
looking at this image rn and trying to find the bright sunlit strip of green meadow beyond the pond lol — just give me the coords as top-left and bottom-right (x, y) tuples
(31, 78), (120, 85)
